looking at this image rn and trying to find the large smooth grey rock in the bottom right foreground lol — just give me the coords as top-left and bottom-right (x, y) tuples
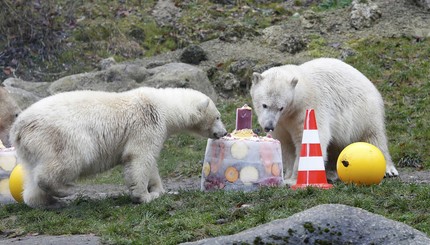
(184, 204), (430, 245)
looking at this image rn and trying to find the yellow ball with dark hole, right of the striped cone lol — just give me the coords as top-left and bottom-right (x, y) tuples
(337, 142), (386, 185)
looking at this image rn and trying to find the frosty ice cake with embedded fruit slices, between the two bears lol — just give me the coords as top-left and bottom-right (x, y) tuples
(201, 105), (283, 191)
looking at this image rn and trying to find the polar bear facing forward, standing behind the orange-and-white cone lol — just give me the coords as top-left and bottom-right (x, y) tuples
(250, 58), (398, 185)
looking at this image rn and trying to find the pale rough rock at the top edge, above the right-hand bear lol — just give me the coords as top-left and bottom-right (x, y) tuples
(350, 0), (382, 30)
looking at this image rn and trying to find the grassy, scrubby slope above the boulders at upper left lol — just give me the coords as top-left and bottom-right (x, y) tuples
(0, 0), (291, 81)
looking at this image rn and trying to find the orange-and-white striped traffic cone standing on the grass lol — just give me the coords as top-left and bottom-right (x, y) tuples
(291, 109), (333, 190)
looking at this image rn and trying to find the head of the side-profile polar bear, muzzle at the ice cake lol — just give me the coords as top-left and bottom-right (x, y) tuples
(191, 97), (227, 139)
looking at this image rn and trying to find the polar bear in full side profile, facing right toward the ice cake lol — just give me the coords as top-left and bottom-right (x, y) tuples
(11, 87), (227, 208)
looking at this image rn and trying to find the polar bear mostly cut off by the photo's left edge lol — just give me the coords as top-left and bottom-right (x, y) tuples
(0, 86), (21, 147)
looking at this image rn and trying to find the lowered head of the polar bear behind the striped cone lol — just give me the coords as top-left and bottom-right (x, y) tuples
(251, 67), (298, 132)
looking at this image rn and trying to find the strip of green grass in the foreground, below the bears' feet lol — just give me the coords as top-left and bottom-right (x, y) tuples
(0, 179), (430, 244)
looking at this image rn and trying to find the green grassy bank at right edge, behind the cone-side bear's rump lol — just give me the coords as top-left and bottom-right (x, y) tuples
(346, 38), (430, 168)
